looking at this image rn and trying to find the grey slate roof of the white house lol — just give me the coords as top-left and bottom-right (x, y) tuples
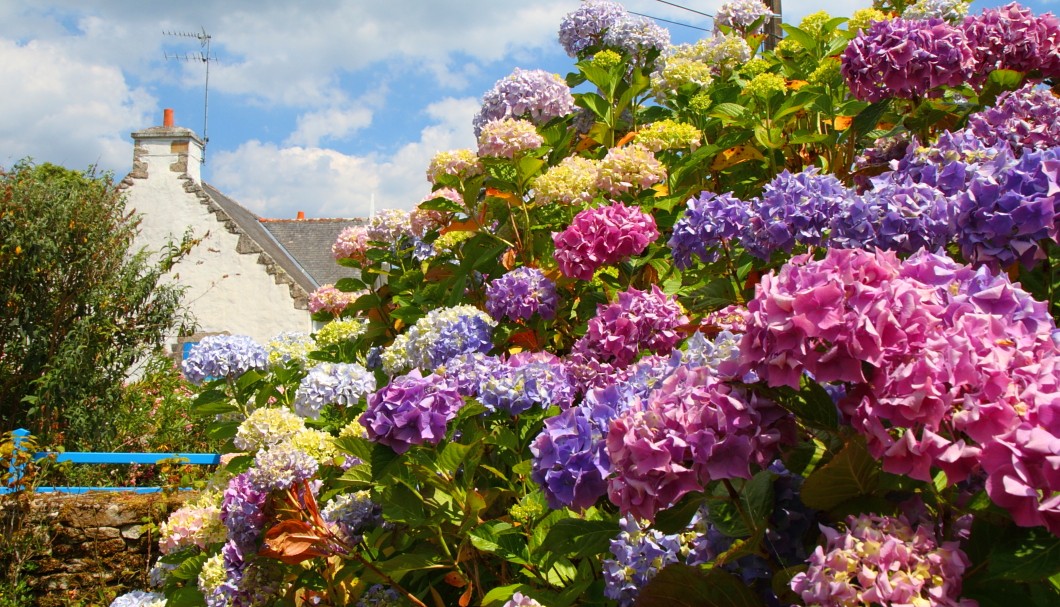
(202, 183), (365, 293)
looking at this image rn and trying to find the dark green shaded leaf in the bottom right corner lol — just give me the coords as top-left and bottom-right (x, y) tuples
(987, 526), (1060, 582)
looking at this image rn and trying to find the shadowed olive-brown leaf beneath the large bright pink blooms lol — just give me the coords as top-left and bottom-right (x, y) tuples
(801, 436), (880, 511)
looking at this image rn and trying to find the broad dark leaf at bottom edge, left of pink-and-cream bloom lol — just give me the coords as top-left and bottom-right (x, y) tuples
(634, 563), (763, 607)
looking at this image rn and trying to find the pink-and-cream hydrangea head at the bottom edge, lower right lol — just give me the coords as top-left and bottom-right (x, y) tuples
(791, 515), (975, 607)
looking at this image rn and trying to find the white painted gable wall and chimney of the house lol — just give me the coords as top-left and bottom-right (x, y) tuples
(125, 131), (312, 344)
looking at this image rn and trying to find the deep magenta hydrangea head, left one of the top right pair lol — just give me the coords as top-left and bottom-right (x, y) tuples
(843, 19), (976, 102)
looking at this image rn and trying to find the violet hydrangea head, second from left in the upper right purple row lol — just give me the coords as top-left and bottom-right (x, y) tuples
(741, 168), (851, 260)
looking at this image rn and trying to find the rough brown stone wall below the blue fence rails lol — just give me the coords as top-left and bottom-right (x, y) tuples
(0, 492), (191, 607)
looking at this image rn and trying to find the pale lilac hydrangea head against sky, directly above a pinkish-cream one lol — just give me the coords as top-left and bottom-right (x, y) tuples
(473, 68), (575, 137)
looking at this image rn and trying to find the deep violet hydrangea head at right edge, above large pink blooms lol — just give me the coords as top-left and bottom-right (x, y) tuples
(956, 148), (1060, 269)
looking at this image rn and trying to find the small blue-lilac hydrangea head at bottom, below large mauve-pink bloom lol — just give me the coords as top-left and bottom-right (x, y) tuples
(603, 515), (683, 607)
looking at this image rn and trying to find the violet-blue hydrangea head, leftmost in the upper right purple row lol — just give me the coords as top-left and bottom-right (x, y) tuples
(668, 192), (750, 264)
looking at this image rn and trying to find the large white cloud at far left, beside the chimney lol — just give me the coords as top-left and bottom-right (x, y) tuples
(0, 38), (156, 171)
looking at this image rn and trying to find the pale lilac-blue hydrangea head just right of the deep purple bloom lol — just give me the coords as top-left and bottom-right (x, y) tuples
(478, 355), (575, 415)
